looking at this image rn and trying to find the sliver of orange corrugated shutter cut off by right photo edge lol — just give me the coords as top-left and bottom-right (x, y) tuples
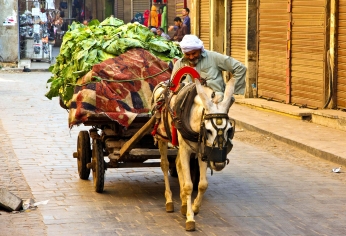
(336, 0), (346, 109)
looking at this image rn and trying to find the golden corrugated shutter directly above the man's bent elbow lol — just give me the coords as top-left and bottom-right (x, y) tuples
(230, 0), (246, 64)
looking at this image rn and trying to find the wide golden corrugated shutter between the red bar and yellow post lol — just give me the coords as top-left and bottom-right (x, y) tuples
(291, 0), (326, 108)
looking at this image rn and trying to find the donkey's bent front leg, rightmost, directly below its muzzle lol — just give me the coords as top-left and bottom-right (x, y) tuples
(192, 158), (208, 214)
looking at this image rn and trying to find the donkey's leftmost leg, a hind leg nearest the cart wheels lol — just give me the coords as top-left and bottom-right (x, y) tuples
(158, 140), (174, 212)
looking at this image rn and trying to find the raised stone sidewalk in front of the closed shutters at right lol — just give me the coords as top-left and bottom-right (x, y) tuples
(229, 99), (346, 165)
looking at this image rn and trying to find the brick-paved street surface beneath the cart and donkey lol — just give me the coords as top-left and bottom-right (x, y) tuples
(0, 73), (346, 236)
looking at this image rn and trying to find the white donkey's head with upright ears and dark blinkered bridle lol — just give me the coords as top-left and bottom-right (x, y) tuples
(196, 79), (234, 171)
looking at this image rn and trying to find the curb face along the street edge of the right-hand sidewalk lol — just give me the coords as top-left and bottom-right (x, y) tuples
(235, 119), (346, 166)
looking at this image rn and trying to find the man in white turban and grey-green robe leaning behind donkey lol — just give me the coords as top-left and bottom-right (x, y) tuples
(172, 34), (246, 103)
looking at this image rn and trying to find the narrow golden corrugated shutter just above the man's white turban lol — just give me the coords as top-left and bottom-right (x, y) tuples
(199, 0), (210, 50)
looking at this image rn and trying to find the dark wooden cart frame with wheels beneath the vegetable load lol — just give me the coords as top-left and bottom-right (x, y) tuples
(73, 114), (199, 193)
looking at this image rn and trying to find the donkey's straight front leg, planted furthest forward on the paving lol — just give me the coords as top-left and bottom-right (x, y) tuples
(179, 143), (195, 231)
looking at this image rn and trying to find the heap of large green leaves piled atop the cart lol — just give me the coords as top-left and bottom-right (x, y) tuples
(45, 17), (182, 104)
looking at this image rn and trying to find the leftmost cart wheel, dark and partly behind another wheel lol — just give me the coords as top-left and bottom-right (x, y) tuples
(77, 130), (91, 180)
